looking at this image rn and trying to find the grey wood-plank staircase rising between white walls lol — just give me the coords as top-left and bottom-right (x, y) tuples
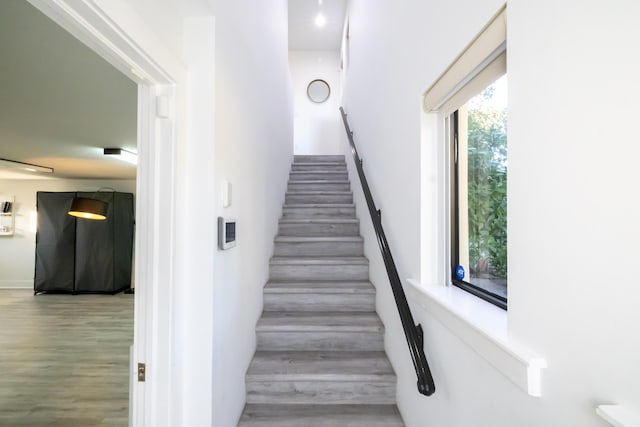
(239, 156), (404, 427)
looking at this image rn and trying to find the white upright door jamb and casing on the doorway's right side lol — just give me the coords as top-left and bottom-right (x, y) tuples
(130, 85), (180, 427)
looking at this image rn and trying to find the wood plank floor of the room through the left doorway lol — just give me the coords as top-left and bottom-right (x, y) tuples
(0, 290), (133, 427)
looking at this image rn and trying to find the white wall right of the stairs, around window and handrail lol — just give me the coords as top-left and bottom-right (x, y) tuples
(344, 0), (640, 427)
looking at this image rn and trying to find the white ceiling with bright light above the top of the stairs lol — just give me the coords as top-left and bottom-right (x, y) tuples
(289, 0), (346, 50)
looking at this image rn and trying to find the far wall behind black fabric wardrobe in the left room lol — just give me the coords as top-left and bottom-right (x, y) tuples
(0, 179), (136, 289)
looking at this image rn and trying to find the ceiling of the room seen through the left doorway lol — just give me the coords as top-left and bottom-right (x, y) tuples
(0, 0), (137, 179)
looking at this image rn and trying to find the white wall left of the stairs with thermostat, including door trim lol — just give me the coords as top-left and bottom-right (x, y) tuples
(45, 0), (293, 427)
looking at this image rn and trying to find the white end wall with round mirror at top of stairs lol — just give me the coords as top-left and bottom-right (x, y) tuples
(289, 50), (342, 154)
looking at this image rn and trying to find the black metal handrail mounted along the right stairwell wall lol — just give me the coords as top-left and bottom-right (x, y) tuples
(340, 107), (436, 396)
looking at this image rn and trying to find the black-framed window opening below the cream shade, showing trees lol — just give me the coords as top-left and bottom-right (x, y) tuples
(448, 74), (507, 308)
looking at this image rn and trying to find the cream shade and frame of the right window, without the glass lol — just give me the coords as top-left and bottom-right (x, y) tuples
(421, 4), (507, 309)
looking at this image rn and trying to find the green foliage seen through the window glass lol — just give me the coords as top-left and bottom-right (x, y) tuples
(468, 88), (507, 279)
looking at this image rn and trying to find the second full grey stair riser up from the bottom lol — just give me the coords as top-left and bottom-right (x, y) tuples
(257, 331), (384, 351)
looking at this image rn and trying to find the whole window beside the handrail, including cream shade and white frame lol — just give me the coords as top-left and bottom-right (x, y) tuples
(423, 7), (508, 309)
